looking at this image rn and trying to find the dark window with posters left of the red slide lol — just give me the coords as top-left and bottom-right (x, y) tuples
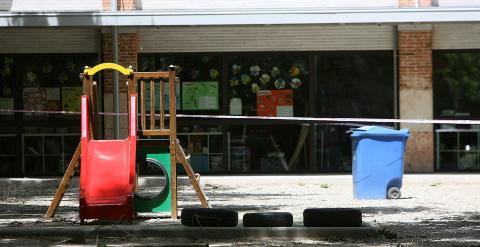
(17, 54), (96, 121)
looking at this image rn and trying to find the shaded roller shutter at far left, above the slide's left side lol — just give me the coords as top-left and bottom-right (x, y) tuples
(0, 28), (98, 53)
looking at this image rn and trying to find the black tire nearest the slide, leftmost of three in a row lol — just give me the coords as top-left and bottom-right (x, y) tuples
(180, 208), (238, 227)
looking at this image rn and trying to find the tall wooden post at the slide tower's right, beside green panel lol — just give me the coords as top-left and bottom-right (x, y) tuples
(168, 65), (178, 219)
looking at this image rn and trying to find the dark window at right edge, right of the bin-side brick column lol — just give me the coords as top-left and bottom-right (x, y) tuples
(433, 50), (480, 171)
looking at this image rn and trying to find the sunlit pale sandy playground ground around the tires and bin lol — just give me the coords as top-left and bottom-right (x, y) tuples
(0, 174), (480, 246)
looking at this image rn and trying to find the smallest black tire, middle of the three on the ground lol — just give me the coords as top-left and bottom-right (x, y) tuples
(243, 212), (293, 227)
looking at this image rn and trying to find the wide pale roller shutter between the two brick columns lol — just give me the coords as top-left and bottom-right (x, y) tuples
(139, 25), (393, 52)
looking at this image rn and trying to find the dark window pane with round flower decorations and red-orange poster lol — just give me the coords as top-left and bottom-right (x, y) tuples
(227, 53), (309, 117)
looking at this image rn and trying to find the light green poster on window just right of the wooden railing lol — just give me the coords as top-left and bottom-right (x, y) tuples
(182, 81), (218, 110)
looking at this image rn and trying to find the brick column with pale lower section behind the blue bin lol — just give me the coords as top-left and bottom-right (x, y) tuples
(398, 25), (434, 172)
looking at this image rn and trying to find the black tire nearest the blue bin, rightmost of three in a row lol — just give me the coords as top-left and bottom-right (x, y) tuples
(303, 208), (362, 227)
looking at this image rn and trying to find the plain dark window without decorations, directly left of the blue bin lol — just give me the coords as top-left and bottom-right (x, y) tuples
(315, 51), (394, 171)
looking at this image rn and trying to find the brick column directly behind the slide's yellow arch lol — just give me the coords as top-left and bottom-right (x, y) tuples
(102, 29), (138, 139)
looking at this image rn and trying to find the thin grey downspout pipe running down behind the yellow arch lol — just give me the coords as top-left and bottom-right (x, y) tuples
(111, 0), (120, 140)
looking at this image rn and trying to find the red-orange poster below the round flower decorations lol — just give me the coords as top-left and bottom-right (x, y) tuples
(257, 89), (293, 117)
